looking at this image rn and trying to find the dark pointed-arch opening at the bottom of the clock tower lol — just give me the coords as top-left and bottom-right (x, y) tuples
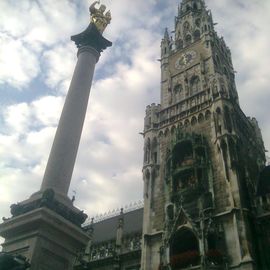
(170, 228), (200, 270)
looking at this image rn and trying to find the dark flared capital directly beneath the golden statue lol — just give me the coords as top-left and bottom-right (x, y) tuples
(71, 23), (112, 53)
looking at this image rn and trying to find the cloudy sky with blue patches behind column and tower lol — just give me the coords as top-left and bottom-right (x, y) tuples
(0, 0), (270, 243)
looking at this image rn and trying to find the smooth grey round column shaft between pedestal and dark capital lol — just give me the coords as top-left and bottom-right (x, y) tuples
(41, 46), (99, 196)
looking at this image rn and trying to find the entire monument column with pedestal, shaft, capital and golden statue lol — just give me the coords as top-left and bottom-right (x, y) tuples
(0, 2), (112, 270)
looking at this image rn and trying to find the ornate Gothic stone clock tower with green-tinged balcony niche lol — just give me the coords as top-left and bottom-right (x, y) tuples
(141, 0), (265, 270)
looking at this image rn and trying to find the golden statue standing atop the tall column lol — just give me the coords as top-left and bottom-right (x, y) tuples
(89, 1), (112, 34)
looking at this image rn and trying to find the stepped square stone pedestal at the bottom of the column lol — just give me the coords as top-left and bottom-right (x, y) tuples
(0, 207), (89, 270)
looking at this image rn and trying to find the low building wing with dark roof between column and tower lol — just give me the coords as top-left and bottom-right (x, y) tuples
(75, 207), (143, 270)
